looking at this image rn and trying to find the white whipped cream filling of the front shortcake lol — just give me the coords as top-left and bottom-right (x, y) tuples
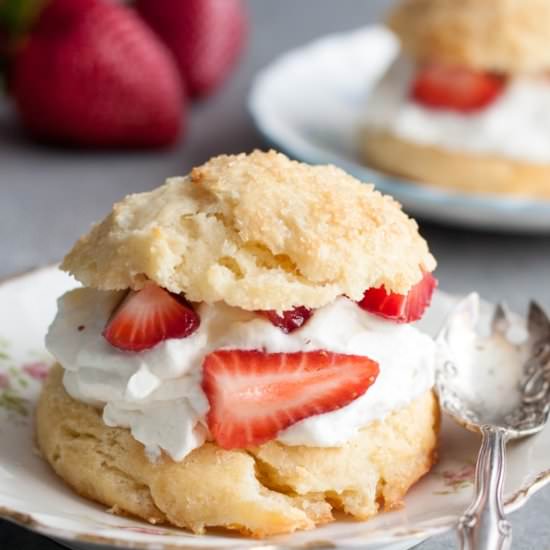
(46, 288), (435, 460)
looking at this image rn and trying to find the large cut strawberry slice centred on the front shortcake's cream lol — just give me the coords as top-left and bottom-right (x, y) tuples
(202, 350), (378, 449)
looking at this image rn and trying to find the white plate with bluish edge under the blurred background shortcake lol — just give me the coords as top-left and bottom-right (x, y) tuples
(249, 26), (550, 232)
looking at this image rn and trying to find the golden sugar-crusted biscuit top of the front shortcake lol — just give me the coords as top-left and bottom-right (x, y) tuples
(61, 151), (435, 311)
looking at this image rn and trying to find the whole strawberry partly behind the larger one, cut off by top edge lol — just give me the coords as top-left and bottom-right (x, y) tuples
(136, 0), (247, 96)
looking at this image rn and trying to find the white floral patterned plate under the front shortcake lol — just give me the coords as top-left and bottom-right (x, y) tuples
(0, 267), (550, 550)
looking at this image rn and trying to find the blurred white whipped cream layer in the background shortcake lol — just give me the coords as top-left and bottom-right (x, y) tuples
(364, 57), (550, 164)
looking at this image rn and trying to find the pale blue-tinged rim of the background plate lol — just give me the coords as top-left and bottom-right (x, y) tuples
(247, 24), (550, 227)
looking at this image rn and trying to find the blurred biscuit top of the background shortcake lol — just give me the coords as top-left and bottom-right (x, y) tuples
(389, 0), (550, 73)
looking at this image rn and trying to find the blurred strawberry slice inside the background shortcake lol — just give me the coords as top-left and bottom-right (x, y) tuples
(411, 65), (505, 113)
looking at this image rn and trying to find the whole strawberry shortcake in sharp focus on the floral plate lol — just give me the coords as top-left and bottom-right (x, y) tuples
(37, 151), (439, 536)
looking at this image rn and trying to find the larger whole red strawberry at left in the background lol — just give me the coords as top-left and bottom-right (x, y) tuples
(12, 0), (184, 147)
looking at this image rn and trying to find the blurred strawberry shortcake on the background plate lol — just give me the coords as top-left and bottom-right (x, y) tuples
(360, 0), (550, 199)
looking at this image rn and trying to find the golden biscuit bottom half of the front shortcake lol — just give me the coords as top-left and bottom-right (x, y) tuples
(36, 365), (439, 537)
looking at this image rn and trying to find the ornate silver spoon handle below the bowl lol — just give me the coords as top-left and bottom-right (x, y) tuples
(458, 425), (512, 550)
